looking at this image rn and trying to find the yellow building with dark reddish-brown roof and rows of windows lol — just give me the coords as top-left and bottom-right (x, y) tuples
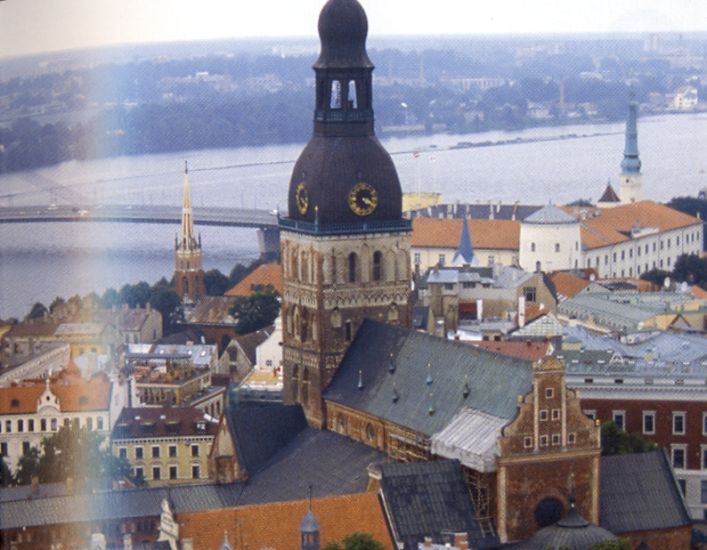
(111, 407), (218, 486)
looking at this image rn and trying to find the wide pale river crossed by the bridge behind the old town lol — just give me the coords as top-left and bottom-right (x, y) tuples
(0, 114), (707, 319)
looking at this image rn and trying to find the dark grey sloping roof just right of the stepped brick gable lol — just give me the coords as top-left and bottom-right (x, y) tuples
(599, 450), (691, 535)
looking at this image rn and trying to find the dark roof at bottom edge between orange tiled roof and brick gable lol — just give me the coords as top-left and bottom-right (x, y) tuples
(378, 460), (499, 548)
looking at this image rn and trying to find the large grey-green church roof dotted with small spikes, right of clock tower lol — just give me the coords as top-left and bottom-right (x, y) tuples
(324, 320), (532, 436)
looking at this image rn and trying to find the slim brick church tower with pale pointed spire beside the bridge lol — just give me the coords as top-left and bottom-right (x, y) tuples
(174, 162), (206, 304)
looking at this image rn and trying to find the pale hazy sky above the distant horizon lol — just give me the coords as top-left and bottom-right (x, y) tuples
(0, 0), (707, 56)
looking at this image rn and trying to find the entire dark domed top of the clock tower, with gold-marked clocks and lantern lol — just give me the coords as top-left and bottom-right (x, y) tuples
(283, 0), (402, 229)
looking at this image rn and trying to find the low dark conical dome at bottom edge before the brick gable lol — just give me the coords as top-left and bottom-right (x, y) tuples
(512, 502), (616, 550)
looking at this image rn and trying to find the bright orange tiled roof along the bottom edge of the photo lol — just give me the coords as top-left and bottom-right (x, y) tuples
(177, 493), (393, 550)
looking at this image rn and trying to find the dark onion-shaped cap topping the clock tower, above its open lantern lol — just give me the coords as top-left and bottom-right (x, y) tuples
(314, 0), (373, 69)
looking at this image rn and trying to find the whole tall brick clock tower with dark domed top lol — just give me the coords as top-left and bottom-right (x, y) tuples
(280, 0), (411, 427)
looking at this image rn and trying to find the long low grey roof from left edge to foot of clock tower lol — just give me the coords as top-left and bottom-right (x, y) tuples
(0, 428), (385, 529)
